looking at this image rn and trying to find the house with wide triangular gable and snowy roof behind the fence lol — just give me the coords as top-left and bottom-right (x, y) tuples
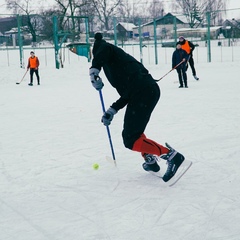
(133, 13), (189, 39)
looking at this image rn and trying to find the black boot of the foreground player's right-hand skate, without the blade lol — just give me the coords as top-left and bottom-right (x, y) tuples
(161, 143), (185, 182)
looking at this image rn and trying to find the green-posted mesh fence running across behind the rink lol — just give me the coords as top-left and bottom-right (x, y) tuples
(0, 9), (240, 66)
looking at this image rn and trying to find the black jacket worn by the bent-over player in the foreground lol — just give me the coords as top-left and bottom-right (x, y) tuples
(91, 39), (156, 111)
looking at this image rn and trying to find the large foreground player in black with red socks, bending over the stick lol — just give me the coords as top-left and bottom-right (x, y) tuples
(89, 33), (184, 182)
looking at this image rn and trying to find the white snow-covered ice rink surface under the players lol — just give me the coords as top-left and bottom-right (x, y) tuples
(0, 43), (240, 240)
